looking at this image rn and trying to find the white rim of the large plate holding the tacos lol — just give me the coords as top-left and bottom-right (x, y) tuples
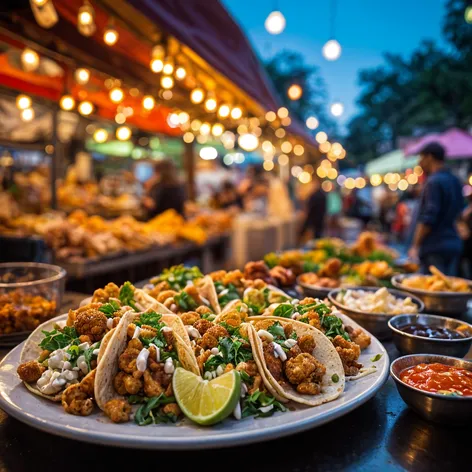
(0, 322), (390, 450)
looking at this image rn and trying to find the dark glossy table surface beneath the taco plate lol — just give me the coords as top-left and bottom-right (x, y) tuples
(0, 294), (470, 472)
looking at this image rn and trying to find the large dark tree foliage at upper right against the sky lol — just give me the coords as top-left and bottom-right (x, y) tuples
(346, 0), (472, 162)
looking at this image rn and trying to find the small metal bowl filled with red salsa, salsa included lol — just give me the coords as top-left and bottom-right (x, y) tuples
(390, 354), (472, 424)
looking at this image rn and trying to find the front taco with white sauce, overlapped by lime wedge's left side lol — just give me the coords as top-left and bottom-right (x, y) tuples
(94, 311), (199, 425)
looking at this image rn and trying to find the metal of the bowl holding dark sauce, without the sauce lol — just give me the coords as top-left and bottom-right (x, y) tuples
(388, 314), (472, 357)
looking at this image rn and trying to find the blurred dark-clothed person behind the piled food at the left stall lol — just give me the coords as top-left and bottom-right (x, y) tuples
(142, 159), (185, 218)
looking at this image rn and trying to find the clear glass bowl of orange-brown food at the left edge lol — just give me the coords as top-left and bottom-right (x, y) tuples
(0, 262), (66, 345)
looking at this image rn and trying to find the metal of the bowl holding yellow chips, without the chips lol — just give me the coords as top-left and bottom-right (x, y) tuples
(392, 274), (472, 315)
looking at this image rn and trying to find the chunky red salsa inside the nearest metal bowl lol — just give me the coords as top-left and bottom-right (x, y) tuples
(400, 363), (472, 396)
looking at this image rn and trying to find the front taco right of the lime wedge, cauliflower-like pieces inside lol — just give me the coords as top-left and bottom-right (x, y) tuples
(248, 317), (345, 406)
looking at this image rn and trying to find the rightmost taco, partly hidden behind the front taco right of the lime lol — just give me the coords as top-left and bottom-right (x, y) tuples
(264, 298), (371, 377)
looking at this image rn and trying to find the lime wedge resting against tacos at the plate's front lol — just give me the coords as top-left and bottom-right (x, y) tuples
(172, 367), (241, 425)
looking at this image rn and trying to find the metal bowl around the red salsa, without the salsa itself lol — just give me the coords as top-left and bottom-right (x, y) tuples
(390, 354), (472, 424)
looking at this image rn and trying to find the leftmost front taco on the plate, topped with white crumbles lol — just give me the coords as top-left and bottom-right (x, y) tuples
(17, 302), (129, 406)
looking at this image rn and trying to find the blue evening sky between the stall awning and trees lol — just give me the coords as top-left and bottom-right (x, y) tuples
(222, 0), (446, 128)
